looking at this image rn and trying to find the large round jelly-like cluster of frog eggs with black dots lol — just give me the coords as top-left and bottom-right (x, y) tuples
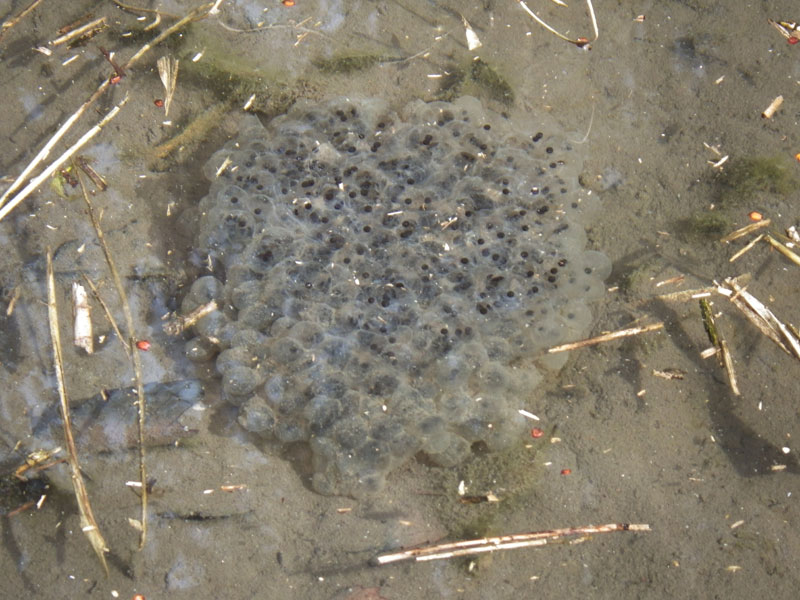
(182, 98), (609, 495)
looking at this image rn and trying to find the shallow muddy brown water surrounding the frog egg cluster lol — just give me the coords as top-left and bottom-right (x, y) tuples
(0, 0), (800, 598)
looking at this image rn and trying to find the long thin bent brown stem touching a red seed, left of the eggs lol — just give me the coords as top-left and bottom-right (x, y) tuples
(76, 173), (148, 548)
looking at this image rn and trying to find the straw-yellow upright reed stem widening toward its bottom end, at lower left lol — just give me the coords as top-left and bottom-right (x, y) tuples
(47, 247), (108, 576)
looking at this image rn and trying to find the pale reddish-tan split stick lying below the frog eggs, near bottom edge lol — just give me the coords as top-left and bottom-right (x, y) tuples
(373, 523), (650, 565)
